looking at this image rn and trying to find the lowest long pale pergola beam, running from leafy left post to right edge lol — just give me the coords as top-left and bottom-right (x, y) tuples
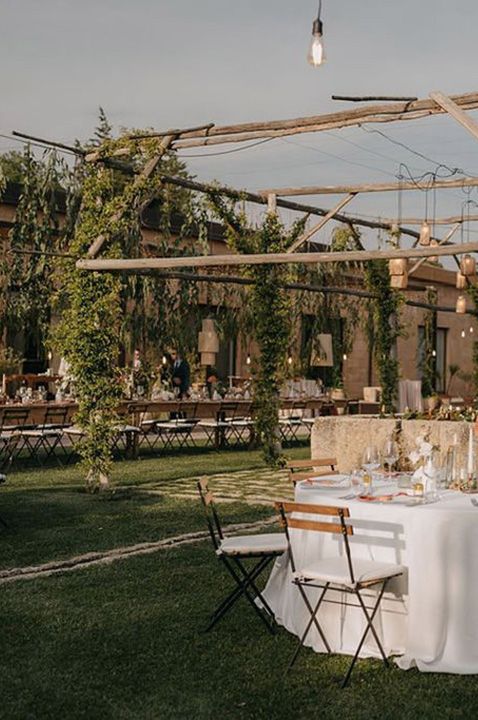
(76, 242), (478, 272)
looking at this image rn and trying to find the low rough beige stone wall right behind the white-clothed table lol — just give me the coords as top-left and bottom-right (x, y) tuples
(311, 416), (477, 472)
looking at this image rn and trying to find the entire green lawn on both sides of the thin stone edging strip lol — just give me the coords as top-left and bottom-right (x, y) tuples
(0, 450), (478, 720)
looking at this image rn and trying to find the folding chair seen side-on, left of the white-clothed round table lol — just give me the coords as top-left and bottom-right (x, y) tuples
(197, 479), (287, 632)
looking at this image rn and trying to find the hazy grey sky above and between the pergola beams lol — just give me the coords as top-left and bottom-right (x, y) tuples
(0, 0), (478, 245)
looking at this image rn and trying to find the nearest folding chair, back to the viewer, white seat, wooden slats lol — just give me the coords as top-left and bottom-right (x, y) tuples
(276, 502), (405, 687)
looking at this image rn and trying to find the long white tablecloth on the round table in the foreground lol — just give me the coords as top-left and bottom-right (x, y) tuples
(265, 483), (478, 674)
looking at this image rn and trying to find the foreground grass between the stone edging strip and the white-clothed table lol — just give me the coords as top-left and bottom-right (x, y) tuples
(0, 543), (478, 720)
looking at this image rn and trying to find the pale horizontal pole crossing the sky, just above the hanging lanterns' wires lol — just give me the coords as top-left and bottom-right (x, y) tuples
(257, 176), (478, 195)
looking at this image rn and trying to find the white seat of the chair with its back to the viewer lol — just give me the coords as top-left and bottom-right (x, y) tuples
(294, 557), (405, 589)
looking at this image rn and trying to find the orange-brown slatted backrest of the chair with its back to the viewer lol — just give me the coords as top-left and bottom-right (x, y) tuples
(275, 501), (355, 583)
